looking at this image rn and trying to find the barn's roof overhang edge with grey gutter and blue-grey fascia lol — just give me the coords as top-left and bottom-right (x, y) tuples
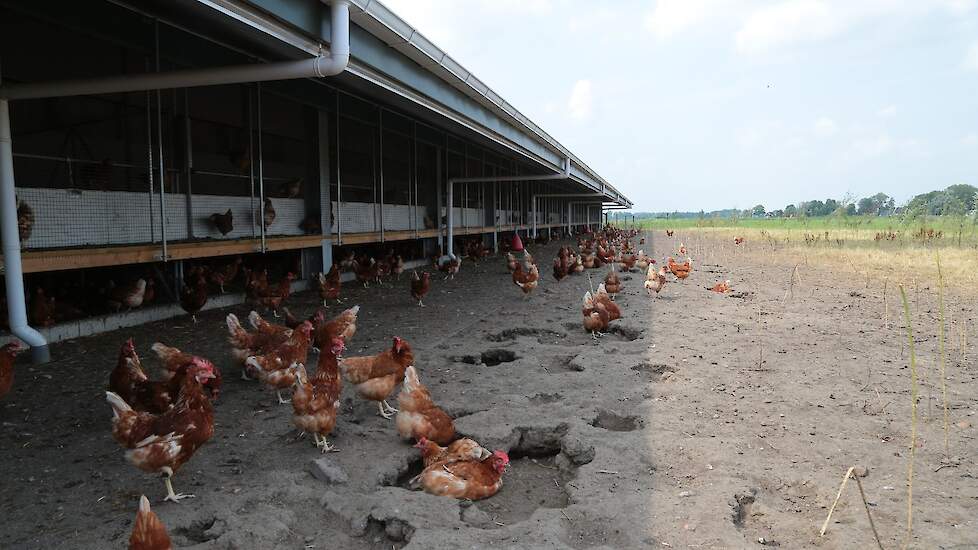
(195, 0), (632, 206)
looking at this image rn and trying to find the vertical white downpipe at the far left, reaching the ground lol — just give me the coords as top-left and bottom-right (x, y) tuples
(0, 99), (51, 363)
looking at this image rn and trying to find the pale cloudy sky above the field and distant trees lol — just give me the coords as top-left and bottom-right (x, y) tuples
(383, 0), (978, 211)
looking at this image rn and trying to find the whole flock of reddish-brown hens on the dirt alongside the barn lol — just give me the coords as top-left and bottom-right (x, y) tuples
(0, 227), (729, 549)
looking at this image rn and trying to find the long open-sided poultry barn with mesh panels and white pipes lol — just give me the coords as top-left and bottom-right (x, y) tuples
(0, 0), (631, 361)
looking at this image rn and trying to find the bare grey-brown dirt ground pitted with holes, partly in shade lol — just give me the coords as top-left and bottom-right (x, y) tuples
(0, 233), (978, 550)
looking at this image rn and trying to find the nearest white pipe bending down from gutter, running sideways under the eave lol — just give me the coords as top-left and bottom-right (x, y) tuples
(0, 0), (350, 100)
